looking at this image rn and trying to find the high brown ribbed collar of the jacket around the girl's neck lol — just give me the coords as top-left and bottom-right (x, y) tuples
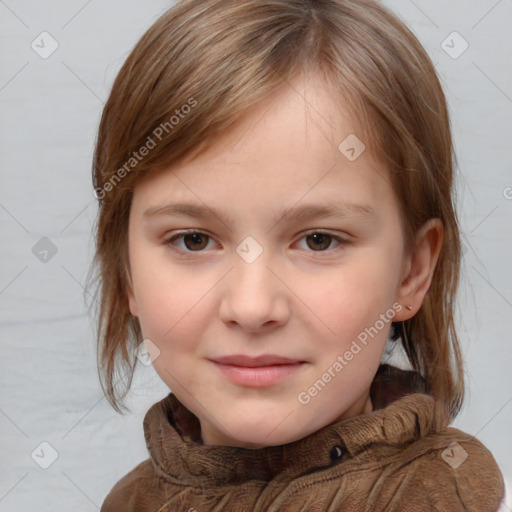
(144, 365), (449, 489)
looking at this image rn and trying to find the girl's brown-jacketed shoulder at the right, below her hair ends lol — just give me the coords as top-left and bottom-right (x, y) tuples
(393, 427), (505, 512)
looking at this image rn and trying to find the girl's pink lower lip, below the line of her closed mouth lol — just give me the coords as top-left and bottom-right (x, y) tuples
(214, 362), (305, 387)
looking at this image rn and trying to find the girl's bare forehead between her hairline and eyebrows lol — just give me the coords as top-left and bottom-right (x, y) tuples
(130, 69), (389, 216)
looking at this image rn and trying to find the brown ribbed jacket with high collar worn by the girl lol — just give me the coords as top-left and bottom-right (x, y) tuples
(101, 365), (504, 512)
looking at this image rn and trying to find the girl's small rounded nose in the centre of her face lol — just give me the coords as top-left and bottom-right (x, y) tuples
(219, 247), (291, 333)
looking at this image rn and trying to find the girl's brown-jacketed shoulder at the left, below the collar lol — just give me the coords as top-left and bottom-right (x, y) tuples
(100, 459), (161, 512)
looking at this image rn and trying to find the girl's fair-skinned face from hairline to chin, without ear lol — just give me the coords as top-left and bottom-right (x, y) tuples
(129, 69), (412, 448)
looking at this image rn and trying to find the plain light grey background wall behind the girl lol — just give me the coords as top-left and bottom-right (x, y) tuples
(0, 0), (512, 512)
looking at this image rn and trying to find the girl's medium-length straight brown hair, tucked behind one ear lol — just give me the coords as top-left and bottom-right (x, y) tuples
(89, 0), (464, 418)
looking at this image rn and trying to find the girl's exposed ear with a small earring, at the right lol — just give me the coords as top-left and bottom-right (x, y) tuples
(395, 219), (444, 321)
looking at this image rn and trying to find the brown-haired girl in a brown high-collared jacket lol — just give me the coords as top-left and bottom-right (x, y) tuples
(89, 0), (504, 512)
